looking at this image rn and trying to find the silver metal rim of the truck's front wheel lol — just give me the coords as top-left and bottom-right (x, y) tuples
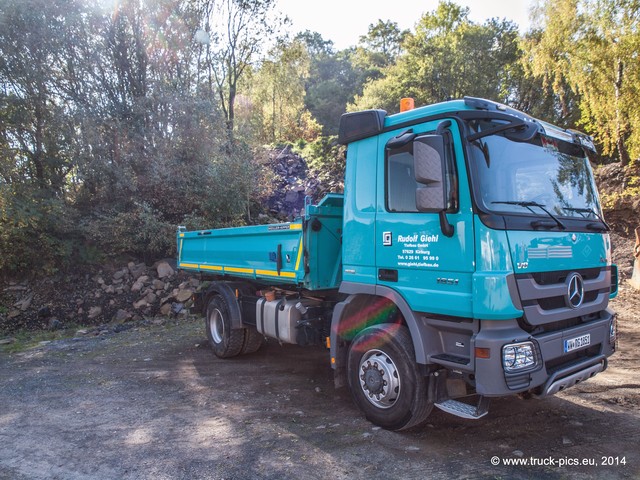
(358, 350), (400, 408)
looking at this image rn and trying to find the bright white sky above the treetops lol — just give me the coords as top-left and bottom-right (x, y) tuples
(276, 0), (535, 50)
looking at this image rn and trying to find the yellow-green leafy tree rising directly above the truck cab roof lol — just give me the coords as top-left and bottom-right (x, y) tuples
(349, 2), (519, 111)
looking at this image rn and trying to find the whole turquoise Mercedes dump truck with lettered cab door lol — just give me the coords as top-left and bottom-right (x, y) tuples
(177, 97), (617, 430)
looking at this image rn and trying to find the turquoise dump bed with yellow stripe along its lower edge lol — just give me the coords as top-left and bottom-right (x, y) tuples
(177, 194), (343, 290)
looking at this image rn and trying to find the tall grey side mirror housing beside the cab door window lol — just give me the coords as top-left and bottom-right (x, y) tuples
(413, 135), (447, 213)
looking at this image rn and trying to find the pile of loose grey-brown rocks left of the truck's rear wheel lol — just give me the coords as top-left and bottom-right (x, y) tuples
(0, 260), (200, 333)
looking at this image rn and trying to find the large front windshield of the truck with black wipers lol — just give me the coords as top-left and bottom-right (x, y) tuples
(469, 120), (600, 221)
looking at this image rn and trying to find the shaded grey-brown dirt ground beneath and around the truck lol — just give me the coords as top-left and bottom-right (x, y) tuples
(0, 284), (640, 480)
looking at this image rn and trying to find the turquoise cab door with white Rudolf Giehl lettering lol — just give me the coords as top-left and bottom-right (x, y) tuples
(375, 119), (474, 317)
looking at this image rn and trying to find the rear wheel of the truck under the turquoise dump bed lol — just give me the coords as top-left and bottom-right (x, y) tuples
(205, 295), (245, 358)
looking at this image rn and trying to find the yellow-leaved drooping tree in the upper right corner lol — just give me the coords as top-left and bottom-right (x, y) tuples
(525, 0), (640, 165)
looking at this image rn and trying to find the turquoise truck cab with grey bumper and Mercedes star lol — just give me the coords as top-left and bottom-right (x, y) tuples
(332, 98), (617, 428)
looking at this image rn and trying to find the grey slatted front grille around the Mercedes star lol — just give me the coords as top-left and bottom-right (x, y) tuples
(516, 267), (611, 331)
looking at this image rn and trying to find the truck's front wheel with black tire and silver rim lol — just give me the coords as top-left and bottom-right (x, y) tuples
(347, 323), (433, 430)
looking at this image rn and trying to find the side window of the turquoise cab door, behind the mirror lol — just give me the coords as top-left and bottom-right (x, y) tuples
(385, 131), (458, 213)
